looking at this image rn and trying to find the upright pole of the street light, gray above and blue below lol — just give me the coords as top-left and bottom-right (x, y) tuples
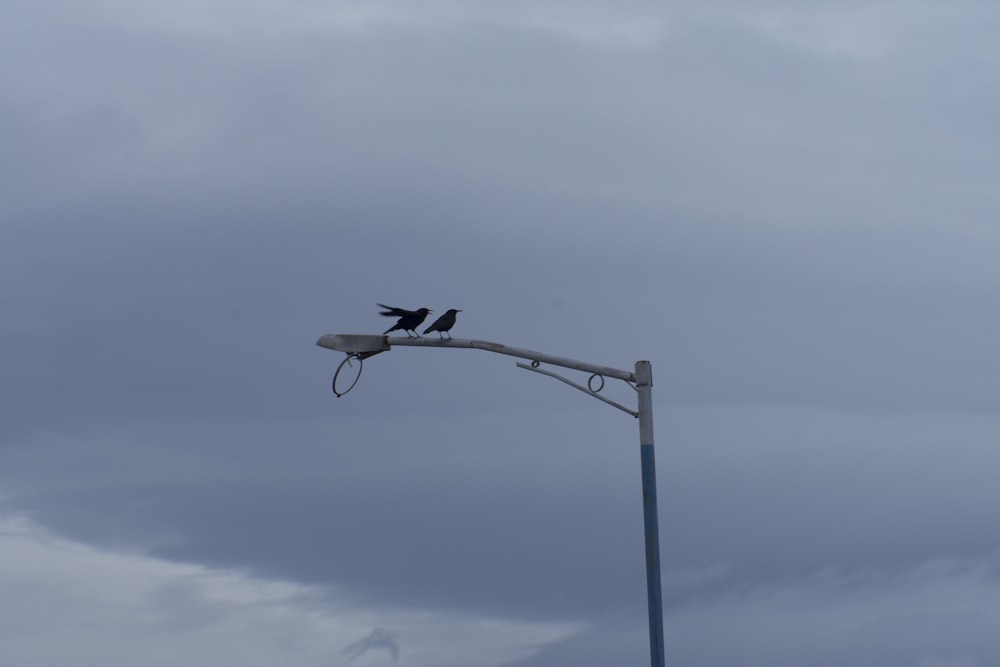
(635, 361), (664, 667)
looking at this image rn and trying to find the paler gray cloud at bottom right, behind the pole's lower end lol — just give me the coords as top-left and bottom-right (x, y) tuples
(509, 561), (997, 667)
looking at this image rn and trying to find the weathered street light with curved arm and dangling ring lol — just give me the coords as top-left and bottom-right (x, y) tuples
(316, 334), (664, 667)
